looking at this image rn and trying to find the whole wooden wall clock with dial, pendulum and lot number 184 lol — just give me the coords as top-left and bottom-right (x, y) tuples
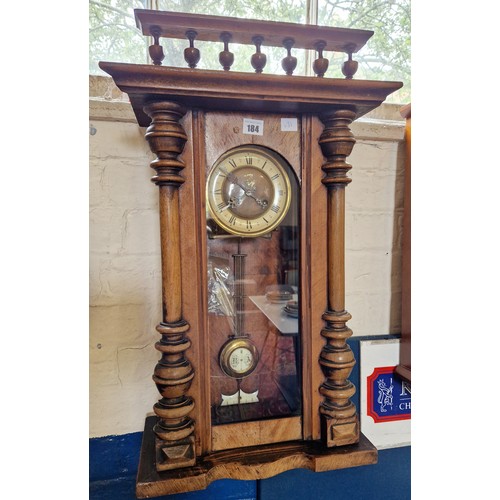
(100, 6), (401, 498)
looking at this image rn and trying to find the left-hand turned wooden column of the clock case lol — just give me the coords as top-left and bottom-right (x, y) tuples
(144, 102), (196, 471)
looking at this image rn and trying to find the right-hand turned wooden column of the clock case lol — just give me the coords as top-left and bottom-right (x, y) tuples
(319, 109), (359, 447)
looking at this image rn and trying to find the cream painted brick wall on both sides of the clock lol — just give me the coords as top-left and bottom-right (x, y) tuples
(89, 77), (404, 437)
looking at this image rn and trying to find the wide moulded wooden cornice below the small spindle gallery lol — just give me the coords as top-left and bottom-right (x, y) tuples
(99, 62), (402, 127)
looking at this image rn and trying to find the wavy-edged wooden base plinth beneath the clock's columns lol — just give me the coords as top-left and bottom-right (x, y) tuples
(136, 416), (377, 498)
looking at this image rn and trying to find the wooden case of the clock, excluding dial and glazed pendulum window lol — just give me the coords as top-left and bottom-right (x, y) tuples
(100, 10), (401, 498)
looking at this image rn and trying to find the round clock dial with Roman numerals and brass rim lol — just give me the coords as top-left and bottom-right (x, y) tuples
(207, 146), (291, 237)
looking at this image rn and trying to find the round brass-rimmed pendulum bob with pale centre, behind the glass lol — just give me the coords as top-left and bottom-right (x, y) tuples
(220, 337), (259, 378)
